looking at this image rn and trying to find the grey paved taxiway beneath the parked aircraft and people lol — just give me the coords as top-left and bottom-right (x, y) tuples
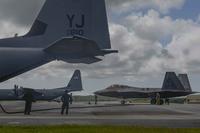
(0, 102), (200, 128)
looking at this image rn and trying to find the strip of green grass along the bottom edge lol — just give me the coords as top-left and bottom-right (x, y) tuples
(0, 125), (200, 133)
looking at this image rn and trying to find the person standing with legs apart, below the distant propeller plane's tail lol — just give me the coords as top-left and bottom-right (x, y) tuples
(61, 92), (72, 115)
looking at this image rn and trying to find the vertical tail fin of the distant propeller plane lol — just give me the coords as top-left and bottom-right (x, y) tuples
(66, 70), (83, 92)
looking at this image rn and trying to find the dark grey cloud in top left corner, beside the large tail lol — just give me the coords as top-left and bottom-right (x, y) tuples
(0, 0), (44, 27)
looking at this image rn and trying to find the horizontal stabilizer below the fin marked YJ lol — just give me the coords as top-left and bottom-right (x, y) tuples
(44, 36), (115, 64)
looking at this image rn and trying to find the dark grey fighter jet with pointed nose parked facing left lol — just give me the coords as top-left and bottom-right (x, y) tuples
(95, 72), (196, 99)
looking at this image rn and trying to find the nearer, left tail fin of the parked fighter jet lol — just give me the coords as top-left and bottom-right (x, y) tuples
(162, 72), (184, 91)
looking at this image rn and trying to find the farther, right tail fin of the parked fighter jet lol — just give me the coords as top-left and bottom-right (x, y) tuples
(178, 74), (192, 92)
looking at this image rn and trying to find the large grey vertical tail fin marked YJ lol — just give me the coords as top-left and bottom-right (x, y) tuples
(24, 0), (111, 49)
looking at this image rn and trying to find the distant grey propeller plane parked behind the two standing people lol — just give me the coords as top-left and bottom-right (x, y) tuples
(0, 70), (83, 101)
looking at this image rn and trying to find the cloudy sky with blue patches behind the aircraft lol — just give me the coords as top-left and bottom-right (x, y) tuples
(0, 0), (200, 94)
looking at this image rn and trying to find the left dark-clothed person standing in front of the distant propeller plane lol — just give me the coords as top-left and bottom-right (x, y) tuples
(23, 92), (33, 115)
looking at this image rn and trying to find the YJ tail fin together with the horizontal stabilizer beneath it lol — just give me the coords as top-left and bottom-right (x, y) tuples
(25, 0), (117, 64)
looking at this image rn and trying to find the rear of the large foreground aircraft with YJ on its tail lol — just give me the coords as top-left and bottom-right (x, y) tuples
(0, 0), (117, 82)
